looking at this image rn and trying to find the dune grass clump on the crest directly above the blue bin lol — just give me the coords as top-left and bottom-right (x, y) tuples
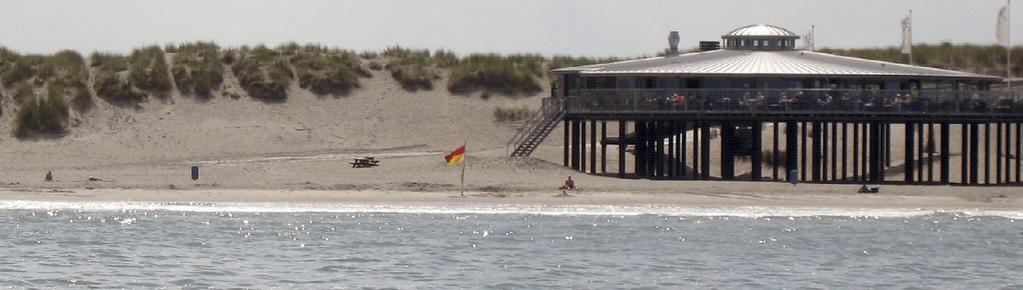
(167, 42), (224, 98)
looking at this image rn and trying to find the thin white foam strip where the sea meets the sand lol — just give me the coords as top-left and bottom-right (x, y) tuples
(0, 201), (1023, 219)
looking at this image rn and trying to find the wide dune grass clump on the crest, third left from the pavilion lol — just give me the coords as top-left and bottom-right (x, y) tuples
(287, 45), (370, 96)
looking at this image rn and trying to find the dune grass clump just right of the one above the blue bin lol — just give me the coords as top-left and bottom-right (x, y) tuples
(229, 45), (294, 101)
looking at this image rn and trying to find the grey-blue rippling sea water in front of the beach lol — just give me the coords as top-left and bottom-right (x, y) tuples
(0, 201), (1023, 289)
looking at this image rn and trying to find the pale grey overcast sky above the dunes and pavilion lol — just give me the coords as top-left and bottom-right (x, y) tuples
(0, 0), (1023, 56)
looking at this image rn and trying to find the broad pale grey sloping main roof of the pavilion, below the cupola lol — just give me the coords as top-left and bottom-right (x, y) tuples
(553, 50), (1000, 81)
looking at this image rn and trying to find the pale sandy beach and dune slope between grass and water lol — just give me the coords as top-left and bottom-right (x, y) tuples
(0, 62), (1023, 209)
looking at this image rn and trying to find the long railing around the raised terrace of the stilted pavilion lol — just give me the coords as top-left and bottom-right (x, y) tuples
(565, 89), (1023, 114)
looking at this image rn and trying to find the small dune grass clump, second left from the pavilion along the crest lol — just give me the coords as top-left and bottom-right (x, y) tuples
(382, 46), (441, 91)
